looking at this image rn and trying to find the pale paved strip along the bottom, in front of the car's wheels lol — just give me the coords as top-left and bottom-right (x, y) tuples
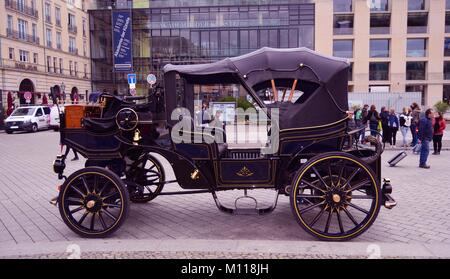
(0, 239), (450, 258)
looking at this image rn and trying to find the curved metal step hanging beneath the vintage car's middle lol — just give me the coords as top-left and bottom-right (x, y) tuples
(212, 189), (279, 215)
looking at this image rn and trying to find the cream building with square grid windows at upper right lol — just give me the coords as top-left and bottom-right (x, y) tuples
(315, 0), (450, 106)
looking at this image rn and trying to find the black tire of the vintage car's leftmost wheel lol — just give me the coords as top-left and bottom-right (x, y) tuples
(58, 167), (129, 238)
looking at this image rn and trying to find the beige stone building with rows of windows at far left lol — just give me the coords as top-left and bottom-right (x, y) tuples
(0, 0), (91, 111)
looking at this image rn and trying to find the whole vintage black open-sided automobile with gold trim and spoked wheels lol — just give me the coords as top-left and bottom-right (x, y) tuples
(54, 48), (396, 240)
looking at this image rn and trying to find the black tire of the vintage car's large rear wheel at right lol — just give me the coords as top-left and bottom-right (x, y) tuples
(290, 152), (382, 241)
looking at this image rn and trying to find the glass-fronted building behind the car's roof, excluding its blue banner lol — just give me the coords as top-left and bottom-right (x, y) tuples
(89, 0), (314, 94)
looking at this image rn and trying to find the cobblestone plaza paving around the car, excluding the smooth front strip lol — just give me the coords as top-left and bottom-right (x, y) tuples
(0, 131), (450, 258)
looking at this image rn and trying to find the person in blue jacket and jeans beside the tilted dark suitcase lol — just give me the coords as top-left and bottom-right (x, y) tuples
(418, 109), (434, 169)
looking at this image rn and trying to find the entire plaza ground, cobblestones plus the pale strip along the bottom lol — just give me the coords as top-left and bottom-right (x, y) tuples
(0, 131), (450, 258)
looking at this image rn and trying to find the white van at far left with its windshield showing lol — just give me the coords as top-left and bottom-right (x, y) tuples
(5, 106), (50, 134)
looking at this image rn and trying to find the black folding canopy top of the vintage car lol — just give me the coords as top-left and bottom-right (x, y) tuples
(163, 47), (349, 129)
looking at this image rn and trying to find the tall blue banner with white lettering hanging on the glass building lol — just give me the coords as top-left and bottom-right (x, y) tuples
(112, 11), (133, 72)
